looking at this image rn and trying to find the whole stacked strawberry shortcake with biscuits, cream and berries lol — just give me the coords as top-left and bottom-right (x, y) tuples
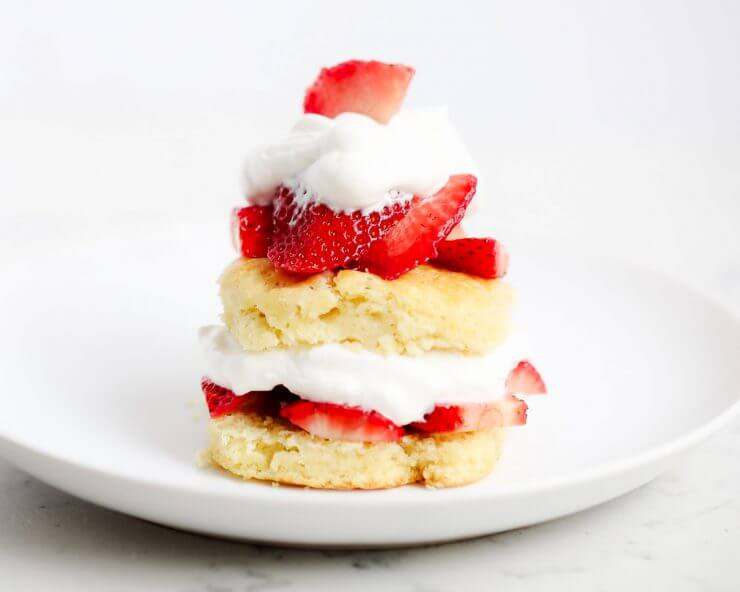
(199, 60), (545, 489)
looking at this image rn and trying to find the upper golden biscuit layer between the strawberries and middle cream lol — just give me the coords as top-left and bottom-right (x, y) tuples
(221, 259), (513, 355)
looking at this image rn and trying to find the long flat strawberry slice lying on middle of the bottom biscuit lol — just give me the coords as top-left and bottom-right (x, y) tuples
(280, 401), (404, 442)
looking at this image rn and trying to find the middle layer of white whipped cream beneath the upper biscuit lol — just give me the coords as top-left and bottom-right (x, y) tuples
(198, 326), (526, 425)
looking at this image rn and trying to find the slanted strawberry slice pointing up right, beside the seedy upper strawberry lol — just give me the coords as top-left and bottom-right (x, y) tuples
(358, 175), (477, 280)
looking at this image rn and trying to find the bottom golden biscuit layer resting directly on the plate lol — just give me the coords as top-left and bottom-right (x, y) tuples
(209, 413), (504, 489)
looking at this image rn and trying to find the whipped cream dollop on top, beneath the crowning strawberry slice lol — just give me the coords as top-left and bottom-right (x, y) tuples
(244, 107), (476, 212)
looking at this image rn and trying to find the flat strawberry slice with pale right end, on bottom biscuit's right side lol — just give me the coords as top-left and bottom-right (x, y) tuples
(411, 395), (527, 433)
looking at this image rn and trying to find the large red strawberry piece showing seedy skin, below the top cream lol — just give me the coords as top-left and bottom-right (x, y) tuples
(267, 187), (411, 273)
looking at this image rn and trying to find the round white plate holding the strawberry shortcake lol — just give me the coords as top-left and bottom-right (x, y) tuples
(0, 223), (740, 546)
